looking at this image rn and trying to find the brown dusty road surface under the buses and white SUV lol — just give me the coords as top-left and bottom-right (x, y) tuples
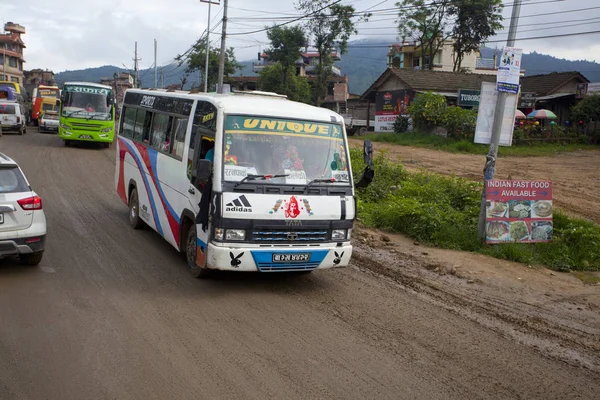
(0, 132), (600, 400)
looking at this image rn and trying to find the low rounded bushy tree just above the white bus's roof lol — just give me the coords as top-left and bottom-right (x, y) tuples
(258, 62), (312, 104)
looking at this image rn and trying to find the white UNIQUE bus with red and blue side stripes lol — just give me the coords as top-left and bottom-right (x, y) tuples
(115, 89), (372, 278)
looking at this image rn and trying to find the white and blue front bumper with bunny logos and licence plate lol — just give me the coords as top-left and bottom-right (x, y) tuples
(206, 242), (352, 272)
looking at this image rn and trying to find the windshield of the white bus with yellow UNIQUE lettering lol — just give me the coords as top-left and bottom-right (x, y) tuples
(223, 115), (350, 185)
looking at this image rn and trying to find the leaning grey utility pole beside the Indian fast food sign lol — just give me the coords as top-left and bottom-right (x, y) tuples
(478, 0), (523, 239)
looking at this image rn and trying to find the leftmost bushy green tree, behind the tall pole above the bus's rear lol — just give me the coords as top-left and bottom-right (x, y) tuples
(175, 39), (243, 90)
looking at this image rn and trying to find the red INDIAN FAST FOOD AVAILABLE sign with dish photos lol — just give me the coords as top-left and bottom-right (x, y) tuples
(486, 180), (553, 243)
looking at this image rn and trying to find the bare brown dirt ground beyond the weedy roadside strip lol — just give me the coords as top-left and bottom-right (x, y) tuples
(351, 139), (600, 224)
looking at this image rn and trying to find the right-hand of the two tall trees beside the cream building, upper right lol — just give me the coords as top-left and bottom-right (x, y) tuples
(448, 0), (504, 72)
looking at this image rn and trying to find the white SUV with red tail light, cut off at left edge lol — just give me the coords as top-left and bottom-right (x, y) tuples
(0, 153), (46, 265)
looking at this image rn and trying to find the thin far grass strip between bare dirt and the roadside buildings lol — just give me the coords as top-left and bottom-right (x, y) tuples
(365, 133), (598, 157)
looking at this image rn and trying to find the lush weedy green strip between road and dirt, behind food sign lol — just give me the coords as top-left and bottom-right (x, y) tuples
(351, 149), (600, 271)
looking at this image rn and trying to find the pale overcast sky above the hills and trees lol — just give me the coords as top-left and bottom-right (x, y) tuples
(0, 0), (600, 72)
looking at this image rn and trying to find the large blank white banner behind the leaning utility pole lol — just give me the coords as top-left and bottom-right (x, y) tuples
(474, 82), (518, 146)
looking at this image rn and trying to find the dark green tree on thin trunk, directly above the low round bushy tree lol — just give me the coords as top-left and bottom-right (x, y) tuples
(266, 26), (306, 87)
